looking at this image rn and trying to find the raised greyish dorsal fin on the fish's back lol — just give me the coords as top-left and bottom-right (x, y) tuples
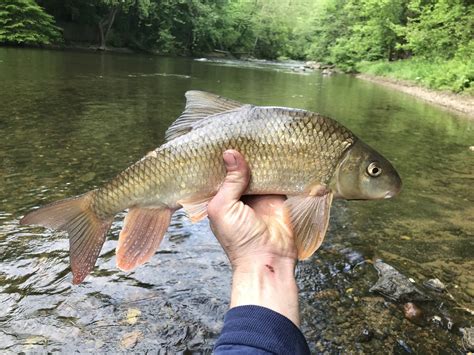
(165, 90), (244, 142)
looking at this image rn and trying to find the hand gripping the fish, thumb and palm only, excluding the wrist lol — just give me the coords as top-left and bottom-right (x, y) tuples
(208, 150), (298, 268)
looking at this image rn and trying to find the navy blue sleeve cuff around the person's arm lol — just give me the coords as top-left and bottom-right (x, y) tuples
(214, 306), (310, 354)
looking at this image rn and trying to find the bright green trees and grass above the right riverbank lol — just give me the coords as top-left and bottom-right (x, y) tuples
(307, 0), (474, 93)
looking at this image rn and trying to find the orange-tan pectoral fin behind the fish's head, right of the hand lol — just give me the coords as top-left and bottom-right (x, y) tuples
(285, 191), (333, 260)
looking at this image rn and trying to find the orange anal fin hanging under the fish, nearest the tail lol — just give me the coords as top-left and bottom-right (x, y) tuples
(116, 207), (174, 271)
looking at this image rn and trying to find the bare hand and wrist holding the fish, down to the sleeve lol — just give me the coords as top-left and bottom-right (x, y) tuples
(207, 150), (299, 325)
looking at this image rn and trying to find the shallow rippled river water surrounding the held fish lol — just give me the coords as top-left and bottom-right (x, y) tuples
(0, 48), (474, 354)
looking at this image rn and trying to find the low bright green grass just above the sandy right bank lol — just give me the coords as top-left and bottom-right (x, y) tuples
(356, 58), (474, 96)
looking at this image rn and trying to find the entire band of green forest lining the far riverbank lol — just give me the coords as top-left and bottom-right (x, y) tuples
(0, 0), (474, 95)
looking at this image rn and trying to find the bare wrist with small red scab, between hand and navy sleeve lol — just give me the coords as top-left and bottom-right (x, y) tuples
(230, 256), (299, 326)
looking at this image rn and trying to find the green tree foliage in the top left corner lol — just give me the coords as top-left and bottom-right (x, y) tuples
(0, 0), (61, 45)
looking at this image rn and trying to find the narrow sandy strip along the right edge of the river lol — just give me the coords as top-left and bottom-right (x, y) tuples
(356, 74), (474, 119)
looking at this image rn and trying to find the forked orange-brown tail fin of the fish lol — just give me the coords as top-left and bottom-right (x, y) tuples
(20, 191), (113, 284)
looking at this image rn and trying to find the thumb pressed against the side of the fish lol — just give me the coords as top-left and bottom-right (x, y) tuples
(209, 150), (250, 214)
